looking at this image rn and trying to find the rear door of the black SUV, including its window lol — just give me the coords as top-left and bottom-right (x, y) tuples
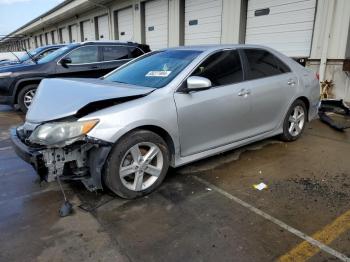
(100, 45), (130, 75)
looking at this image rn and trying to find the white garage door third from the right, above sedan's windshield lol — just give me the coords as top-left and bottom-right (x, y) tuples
(145, 0), (168, 50)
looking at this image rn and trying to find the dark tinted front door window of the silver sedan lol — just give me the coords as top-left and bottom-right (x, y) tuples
(192, 50), (243, 86)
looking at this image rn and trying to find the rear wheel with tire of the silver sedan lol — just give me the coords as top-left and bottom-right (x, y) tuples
(281, 100), (307, 141)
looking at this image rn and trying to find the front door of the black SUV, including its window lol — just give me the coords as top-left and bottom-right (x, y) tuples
(56, 45), (103, 78)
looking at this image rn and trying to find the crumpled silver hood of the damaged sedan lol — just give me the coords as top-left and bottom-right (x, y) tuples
(26, 79), (154, 123)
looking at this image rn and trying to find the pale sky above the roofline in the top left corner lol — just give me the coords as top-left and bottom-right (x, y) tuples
(0, 0), (64, 38)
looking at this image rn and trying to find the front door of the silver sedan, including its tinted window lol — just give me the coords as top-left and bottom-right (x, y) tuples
(174, 50), (251, 156)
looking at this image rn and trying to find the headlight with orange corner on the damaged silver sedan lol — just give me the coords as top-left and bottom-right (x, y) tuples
(29, 119), (98, 146)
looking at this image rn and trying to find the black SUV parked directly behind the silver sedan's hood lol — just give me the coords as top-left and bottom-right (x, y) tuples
(0, 41), (150, 112)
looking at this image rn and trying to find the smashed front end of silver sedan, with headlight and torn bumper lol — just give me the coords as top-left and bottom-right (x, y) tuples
(11, 120), (112, 191)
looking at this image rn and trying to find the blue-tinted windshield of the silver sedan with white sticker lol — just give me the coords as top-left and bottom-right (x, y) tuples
(105, 50), (201, 88)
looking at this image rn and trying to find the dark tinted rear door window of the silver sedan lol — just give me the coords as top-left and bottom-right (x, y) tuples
(244, 49), (290, 80)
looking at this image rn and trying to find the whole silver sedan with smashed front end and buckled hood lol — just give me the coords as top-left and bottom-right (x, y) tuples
(11, 45), (319, 199)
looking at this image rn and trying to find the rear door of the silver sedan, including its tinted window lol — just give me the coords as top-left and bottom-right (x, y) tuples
(242, 49), (298, 135)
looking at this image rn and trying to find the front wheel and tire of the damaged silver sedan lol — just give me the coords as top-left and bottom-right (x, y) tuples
(103, 130), (169, 199)
